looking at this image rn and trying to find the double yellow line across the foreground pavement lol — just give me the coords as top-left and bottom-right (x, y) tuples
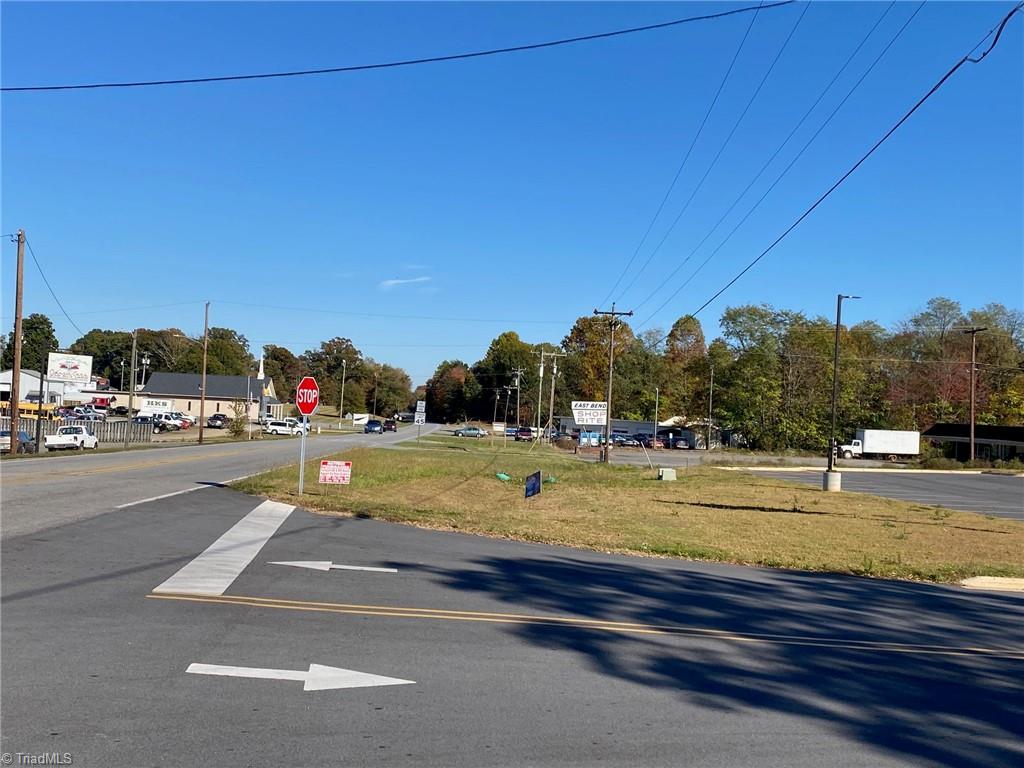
(146, 594), (1024, 660)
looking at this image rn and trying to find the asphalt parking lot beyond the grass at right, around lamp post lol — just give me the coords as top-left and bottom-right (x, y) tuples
(749, 468), (1024, 520)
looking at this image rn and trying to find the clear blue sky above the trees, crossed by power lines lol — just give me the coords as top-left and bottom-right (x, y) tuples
(0, 2), (1024, 382)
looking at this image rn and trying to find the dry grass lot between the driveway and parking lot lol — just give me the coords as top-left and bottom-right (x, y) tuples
(236, 436), (1024, 582)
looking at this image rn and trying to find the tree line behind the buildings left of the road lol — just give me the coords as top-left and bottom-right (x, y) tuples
(0, 313), (415, 416)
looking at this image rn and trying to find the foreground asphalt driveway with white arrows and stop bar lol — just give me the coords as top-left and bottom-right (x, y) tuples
(0, 479), (1024, 768)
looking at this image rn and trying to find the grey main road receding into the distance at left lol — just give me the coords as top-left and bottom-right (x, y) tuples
(0, 425), (436, 538)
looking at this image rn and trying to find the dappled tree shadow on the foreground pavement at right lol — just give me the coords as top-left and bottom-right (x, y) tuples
(406, 556), (1024, 768)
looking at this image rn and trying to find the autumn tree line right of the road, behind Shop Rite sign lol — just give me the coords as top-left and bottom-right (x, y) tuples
(427, 297), (1024, 451)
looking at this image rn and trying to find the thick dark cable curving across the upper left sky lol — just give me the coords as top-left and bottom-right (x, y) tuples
(0, 0), (795, 92)
